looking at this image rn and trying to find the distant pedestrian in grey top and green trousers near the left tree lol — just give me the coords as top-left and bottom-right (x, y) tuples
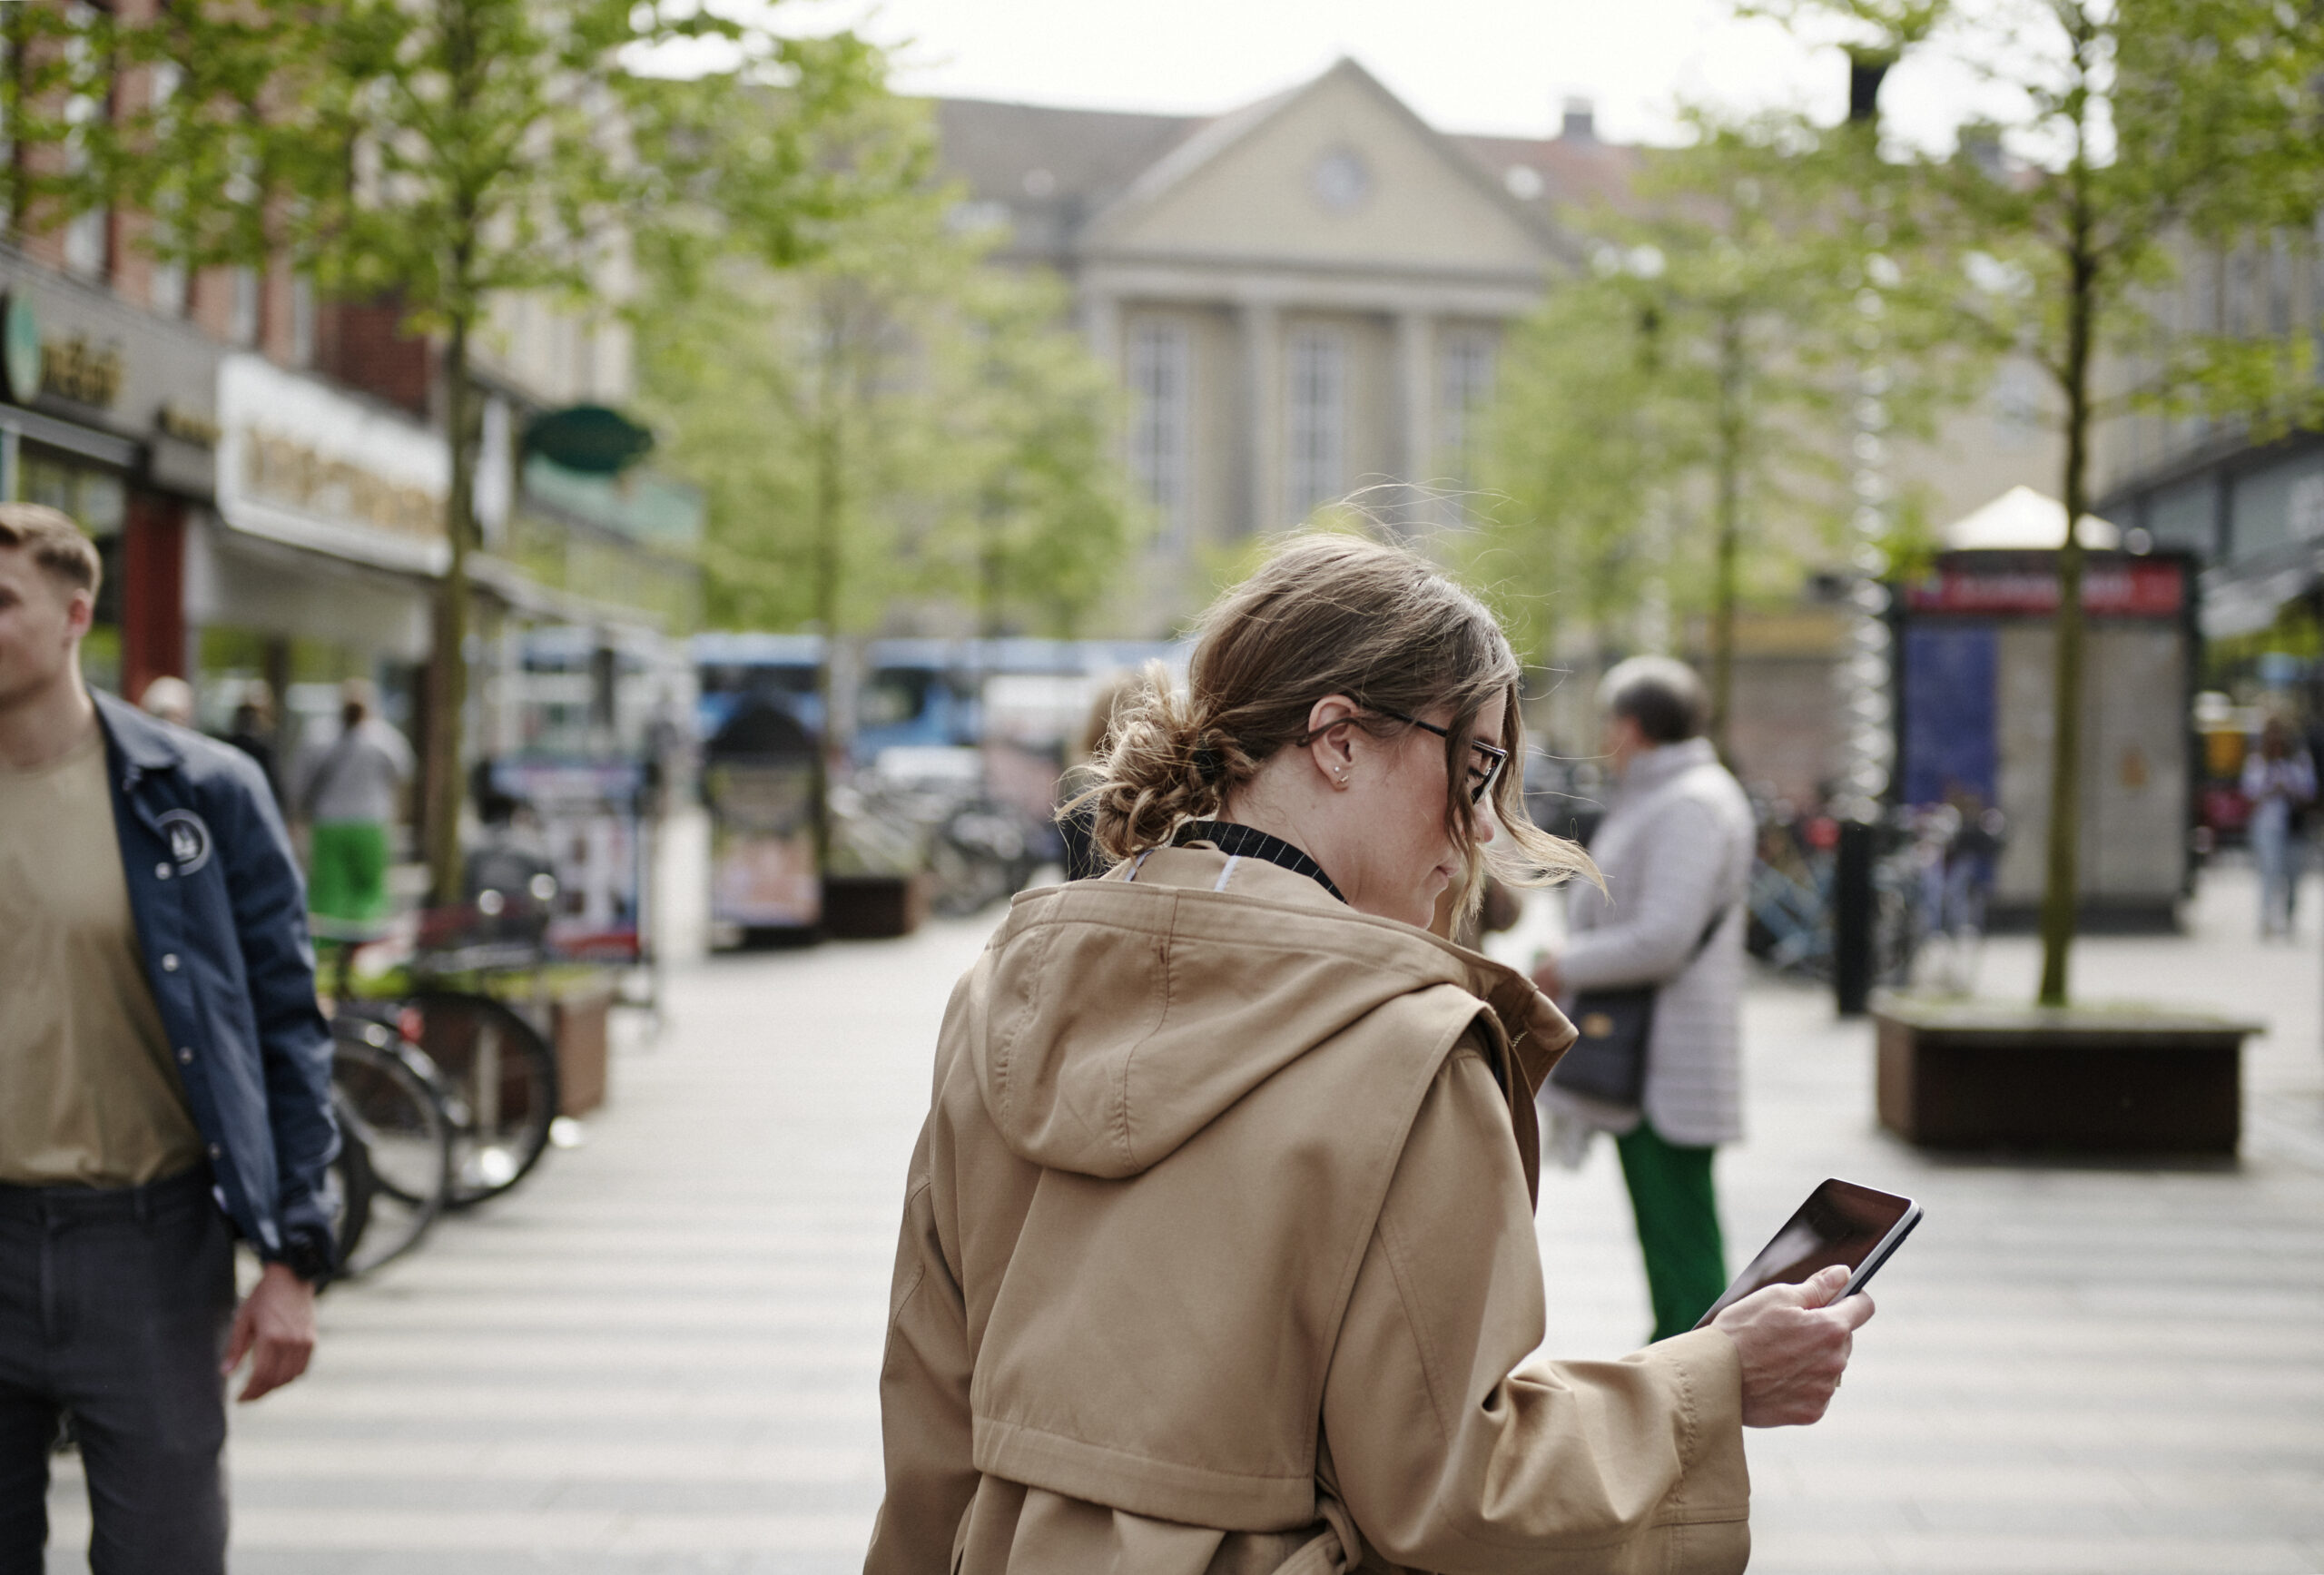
(293, 678), (411, 930)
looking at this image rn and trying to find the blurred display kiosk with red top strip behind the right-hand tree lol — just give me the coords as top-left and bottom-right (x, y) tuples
(1896, 553), (2194, 922)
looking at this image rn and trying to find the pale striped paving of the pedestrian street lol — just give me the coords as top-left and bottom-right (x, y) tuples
(49, 871), (2324, 1575)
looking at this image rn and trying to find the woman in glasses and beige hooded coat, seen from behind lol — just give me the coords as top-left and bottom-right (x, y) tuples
(867, 536), (1871, 1575)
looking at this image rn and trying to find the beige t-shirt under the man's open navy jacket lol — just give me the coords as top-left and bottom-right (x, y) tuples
(0, 724), (202, 1187)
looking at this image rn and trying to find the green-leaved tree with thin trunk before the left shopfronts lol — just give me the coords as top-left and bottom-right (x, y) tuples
(88, 0), (869, 901)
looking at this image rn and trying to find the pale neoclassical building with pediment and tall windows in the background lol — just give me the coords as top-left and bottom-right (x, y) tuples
(937, 61), (1639, 615)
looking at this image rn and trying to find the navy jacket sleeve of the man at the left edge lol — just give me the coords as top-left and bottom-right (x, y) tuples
(221, 755), (340, 1271)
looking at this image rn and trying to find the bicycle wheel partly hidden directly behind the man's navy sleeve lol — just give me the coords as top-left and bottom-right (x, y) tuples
(330, 1018), (458, 1275)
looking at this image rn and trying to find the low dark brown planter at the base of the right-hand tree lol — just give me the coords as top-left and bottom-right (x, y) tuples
(1873, 994), (2261, 1155)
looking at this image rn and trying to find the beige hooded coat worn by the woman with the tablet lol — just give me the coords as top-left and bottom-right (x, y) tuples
(864, 848), (1750, 1575)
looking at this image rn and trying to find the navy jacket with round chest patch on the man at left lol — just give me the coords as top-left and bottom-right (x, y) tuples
(95, 694), (340, 1280)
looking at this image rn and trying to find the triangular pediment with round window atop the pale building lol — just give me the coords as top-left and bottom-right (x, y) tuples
(1080, 61), (1557, 279)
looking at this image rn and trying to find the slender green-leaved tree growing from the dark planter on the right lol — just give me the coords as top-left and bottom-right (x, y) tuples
(1783, 0), (2324, 1006)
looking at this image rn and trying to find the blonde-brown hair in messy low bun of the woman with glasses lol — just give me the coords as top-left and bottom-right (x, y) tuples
(1064, 535), (1597, 901)
